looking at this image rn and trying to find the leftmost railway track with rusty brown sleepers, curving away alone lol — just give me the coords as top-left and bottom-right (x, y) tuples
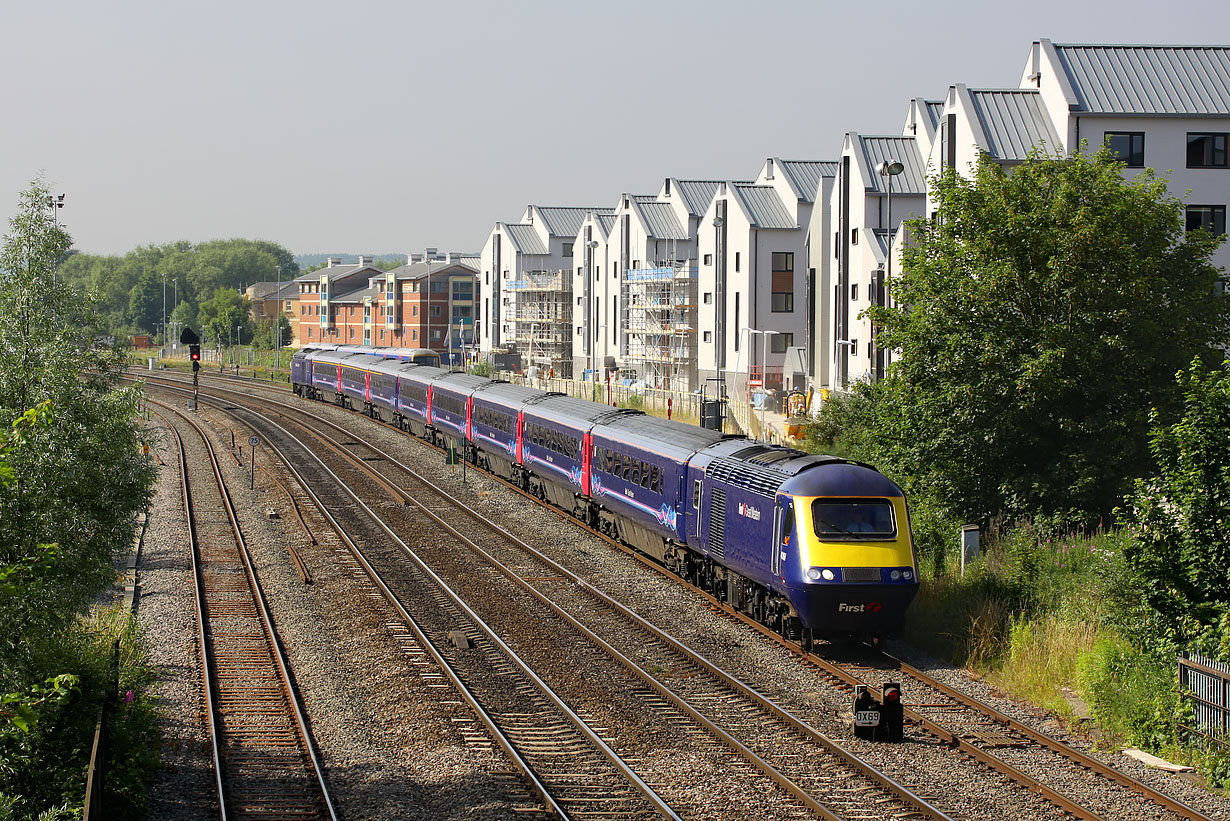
(155, 402), (337, 820)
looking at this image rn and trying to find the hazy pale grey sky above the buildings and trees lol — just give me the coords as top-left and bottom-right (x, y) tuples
(0, 0), (1230, 254)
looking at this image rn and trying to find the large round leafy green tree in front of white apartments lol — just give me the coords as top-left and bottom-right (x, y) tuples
(871, 150), (1230, 524)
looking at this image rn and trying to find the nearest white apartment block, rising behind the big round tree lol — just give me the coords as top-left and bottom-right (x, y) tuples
(813, 39), (1230, 389)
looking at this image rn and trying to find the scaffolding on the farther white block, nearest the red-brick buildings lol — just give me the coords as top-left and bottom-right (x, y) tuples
(506, 271), (573, 378)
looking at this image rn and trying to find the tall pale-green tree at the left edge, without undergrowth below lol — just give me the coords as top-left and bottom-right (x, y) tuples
(0, 181), (153, 686)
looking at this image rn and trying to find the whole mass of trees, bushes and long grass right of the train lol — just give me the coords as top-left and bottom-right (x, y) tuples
(809, 150), (1230, 785)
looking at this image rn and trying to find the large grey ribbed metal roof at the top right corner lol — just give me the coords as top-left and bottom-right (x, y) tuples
(1042, 41), (1230, 117)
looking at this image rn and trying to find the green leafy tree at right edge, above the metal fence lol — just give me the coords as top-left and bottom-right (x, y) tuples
(1125, 359), (1230, 659)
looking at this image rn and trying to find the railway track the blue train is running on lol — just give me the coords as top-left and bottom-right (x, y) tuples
(141, 374), (1208, 819)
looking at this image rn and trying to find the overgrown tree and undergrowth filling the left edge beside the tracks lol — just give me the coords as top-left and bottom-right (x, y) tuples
(0, 182), (154, 819)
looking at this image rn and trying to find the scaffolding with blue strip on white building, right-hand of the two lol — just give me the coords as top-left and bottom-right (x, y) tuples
(620, 263), (697, 391)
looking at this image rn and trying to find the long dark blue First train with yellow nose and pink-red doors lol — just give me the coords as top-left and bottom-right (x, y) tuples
(290, 347), (919, 647)
